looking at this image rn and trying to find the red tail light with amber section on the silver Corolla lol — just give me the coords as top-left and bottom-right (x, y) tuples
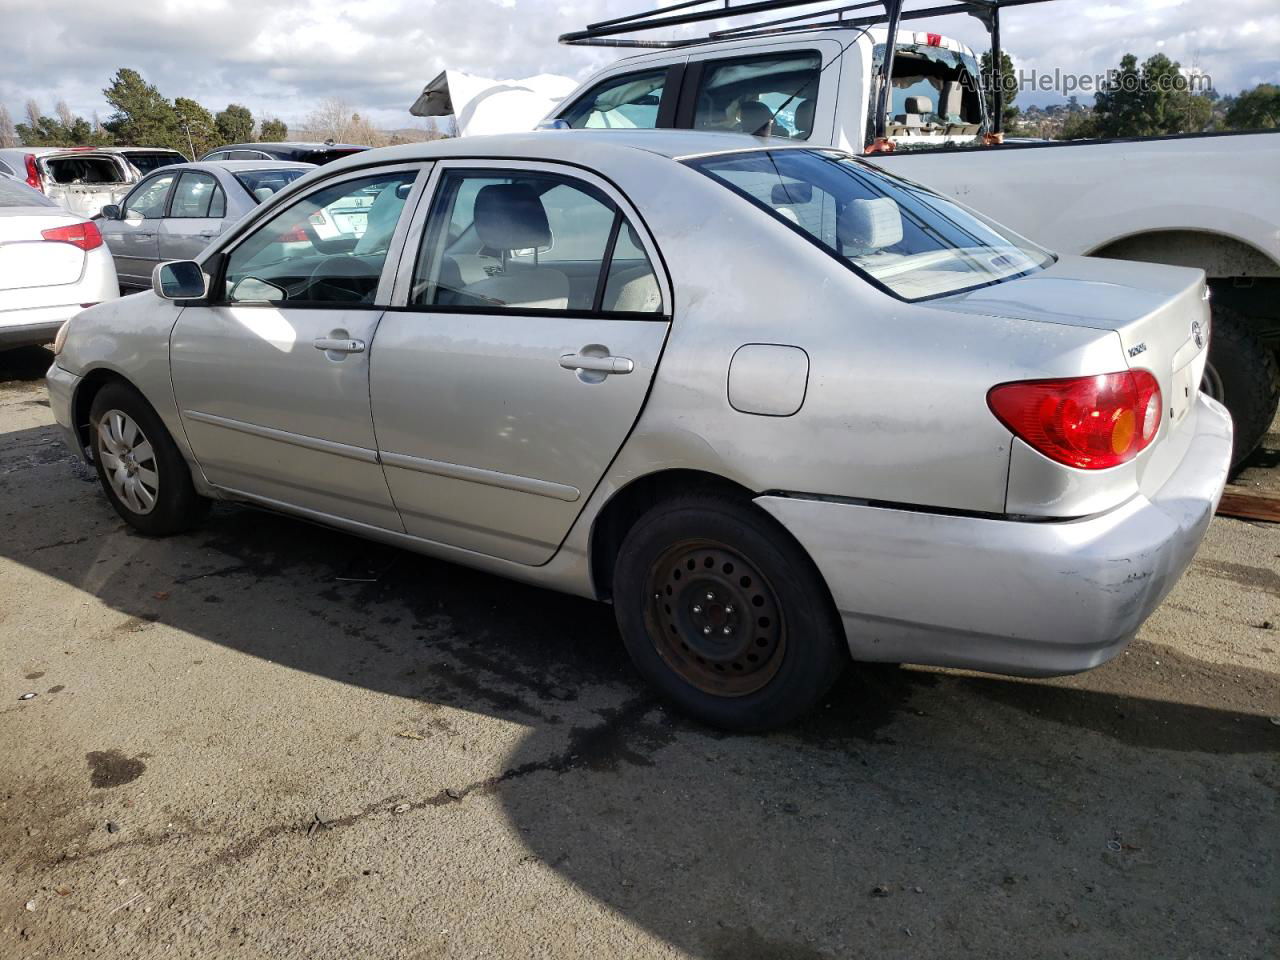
(987, 370), (1164, 470)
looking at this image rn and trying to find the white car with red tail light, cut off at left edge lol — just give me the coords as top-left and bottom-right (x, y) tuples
(0, 177), (120, 349)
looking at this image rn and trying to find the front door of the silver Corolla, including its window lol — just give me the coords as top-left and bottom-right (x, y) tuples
(166, 166), (420, 531)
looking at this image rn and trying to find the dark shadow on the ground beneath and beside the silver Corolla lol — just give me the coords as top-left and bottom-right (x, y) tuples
(0, 428), (1280, 960)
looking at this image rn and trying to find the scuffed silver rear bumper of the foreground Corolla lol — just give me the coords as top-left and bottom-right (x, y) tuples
(756, 396), (1231, 676)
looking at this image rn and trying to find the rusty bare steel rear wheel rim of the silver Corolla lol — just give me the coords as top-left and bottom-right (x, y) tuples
(645, 540), (786, 696)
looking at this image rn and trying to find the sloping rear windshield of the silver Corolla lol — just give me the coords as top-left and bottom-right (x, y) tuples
(686, 150), (1053, 301)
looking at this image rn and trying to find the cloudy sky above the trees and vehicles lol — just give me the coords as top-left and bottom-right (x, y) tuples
(0, 0), (1280, 127)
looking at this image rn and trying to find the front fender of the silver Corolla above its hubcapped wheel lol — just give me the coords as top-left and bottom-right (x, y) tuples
(58, 291), (200, 471)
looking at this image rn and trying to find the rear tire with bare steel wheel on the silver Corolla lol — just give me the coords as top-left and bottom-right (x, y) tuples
(613, 494), (849, 731)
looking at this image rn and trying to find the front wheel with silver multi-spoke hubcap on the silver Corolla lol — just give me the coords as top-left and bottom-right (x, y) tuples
(90, 383), (209, 536)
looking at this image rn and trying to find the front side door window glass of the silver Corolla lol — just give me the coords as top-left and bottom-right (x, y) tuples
(216, 170), (416, 305)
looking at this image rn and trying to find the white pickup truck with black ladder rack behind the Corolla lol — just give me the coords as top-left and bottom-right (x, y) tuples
(540, 0), (1280, 463)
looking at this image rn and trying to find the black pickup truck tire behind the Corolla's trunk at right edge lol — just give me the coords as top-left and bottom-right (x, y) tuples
(1201, 306), (1280, 470)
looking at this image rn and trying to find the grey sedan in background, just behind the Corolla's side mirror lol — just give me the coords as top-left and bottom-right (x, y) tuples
(99, 160), (312, 288)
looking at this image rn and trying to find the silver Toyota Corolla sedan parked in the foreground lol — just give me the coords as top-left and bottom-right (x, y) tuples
(49, 131), (1231, 730)
